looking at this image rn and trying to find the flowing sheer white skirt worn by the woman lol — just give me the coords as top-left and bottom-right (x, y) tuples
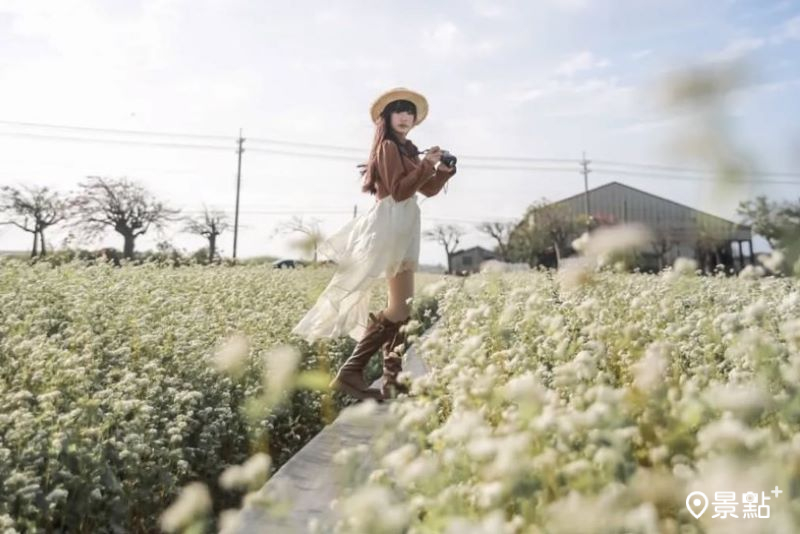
(292, 194), (420, 343)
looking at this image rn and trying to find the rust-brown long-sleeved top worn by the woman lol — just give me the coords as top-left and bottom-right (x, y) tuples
(375, 139), (456, 202)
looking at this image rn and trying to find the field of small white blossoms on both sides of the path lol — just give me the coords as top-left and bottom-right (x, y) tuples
(0, 261), (800, 534)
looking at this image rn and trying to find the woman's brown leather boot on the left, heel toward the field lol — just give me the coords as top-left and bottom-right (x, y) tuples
(330, 310), (394, 402)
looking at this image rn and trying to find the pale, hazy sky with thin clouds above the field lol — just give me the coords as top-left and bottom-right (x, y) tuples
(0, 0), (800, 264)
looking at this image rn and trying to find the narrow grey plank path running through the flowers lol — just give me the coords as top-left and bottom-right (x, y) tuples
(233, 324), (428, 534)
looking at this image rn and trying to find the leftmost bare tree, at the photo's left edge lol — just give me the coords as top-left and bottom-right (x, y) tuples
(0, 186), (69, 258)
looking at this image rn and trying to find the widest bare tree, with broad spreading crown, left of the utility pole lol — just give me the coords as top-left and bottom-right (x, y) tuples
(72, 176), (180, 259)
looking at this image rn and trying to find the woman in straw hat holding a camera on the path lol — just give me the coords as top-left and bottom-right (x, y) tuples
(292, 87), (456, 401)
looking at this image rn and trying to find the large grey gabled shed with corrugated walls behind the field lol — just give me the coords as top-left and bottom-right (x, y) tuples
(532, 182), (755, 271)
